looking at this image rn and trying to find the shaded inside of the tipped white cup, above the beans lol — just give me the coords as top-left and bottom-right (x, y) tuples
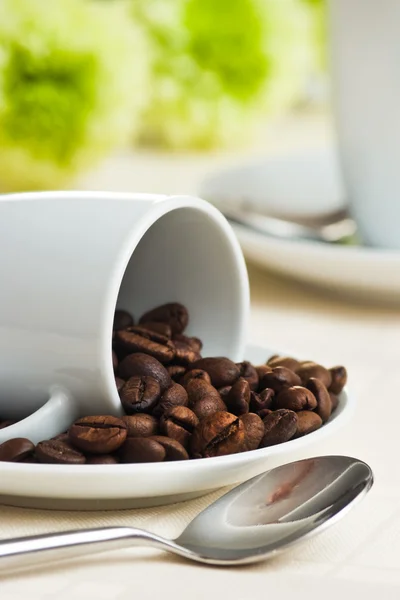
(116, 207), (248, 360)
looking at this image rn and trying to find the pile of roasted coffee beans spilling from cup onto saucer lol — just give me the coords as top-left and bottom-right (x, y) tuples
(0, 302), (347, 465)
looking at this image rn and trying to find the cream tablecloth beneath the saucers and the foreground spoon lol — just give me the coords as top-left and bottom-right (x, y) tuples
(0, 113), (400, 600)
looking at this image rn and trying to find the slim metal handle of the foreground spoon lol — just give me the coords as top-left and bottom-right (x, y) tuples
(0, 527), (169, 569)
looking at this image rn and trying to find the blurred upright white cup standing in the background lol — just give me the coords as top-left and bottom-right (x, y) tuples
(329, 0), (400, 249)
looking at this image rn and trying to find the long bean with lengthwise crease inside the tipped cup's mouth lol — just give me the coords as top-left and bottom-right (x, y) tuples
(115, 327), (175, 364)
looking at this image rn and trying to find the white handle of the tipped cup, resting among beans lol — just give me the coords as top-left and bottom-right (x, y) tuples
(0, 388), (79, 444)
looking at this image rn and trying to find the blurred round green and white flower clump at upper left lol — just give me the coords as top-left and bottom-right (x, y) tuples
(0, 0), (147, 190)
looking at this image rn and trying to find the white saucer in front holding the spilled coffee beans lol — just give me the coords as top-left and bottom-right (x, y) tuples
(0, 346), (353, 510)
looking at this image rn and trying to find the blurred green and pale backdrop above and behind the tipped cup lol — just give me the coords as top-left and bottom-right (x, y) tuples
(0, 0), (330, 192)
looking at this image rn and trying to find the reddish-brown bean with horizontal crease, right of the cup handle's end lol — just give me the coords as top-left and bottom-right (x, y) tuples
(68, 415), (128, 454)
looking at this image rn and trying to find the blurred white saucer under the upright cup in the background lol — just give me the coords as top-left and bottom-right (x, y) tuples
(199, 149), (400, 301)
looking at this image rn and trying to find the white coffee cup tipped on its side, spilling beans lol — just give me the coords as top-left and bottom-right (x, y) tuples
(0, 192), (249, 443)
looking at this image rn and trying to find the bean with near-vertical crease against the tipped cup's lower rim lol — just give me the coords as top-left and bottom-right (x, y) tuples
(120, 376), (161, 415)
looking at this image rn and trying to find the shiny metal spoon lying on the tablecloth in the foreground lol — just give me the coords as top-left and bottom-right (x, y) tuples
(0, 456), (373, 569)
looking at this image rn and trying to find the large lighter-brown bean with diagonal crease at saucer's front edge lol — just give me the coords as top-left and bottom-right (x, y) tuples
(190, 412), (246, 458)
